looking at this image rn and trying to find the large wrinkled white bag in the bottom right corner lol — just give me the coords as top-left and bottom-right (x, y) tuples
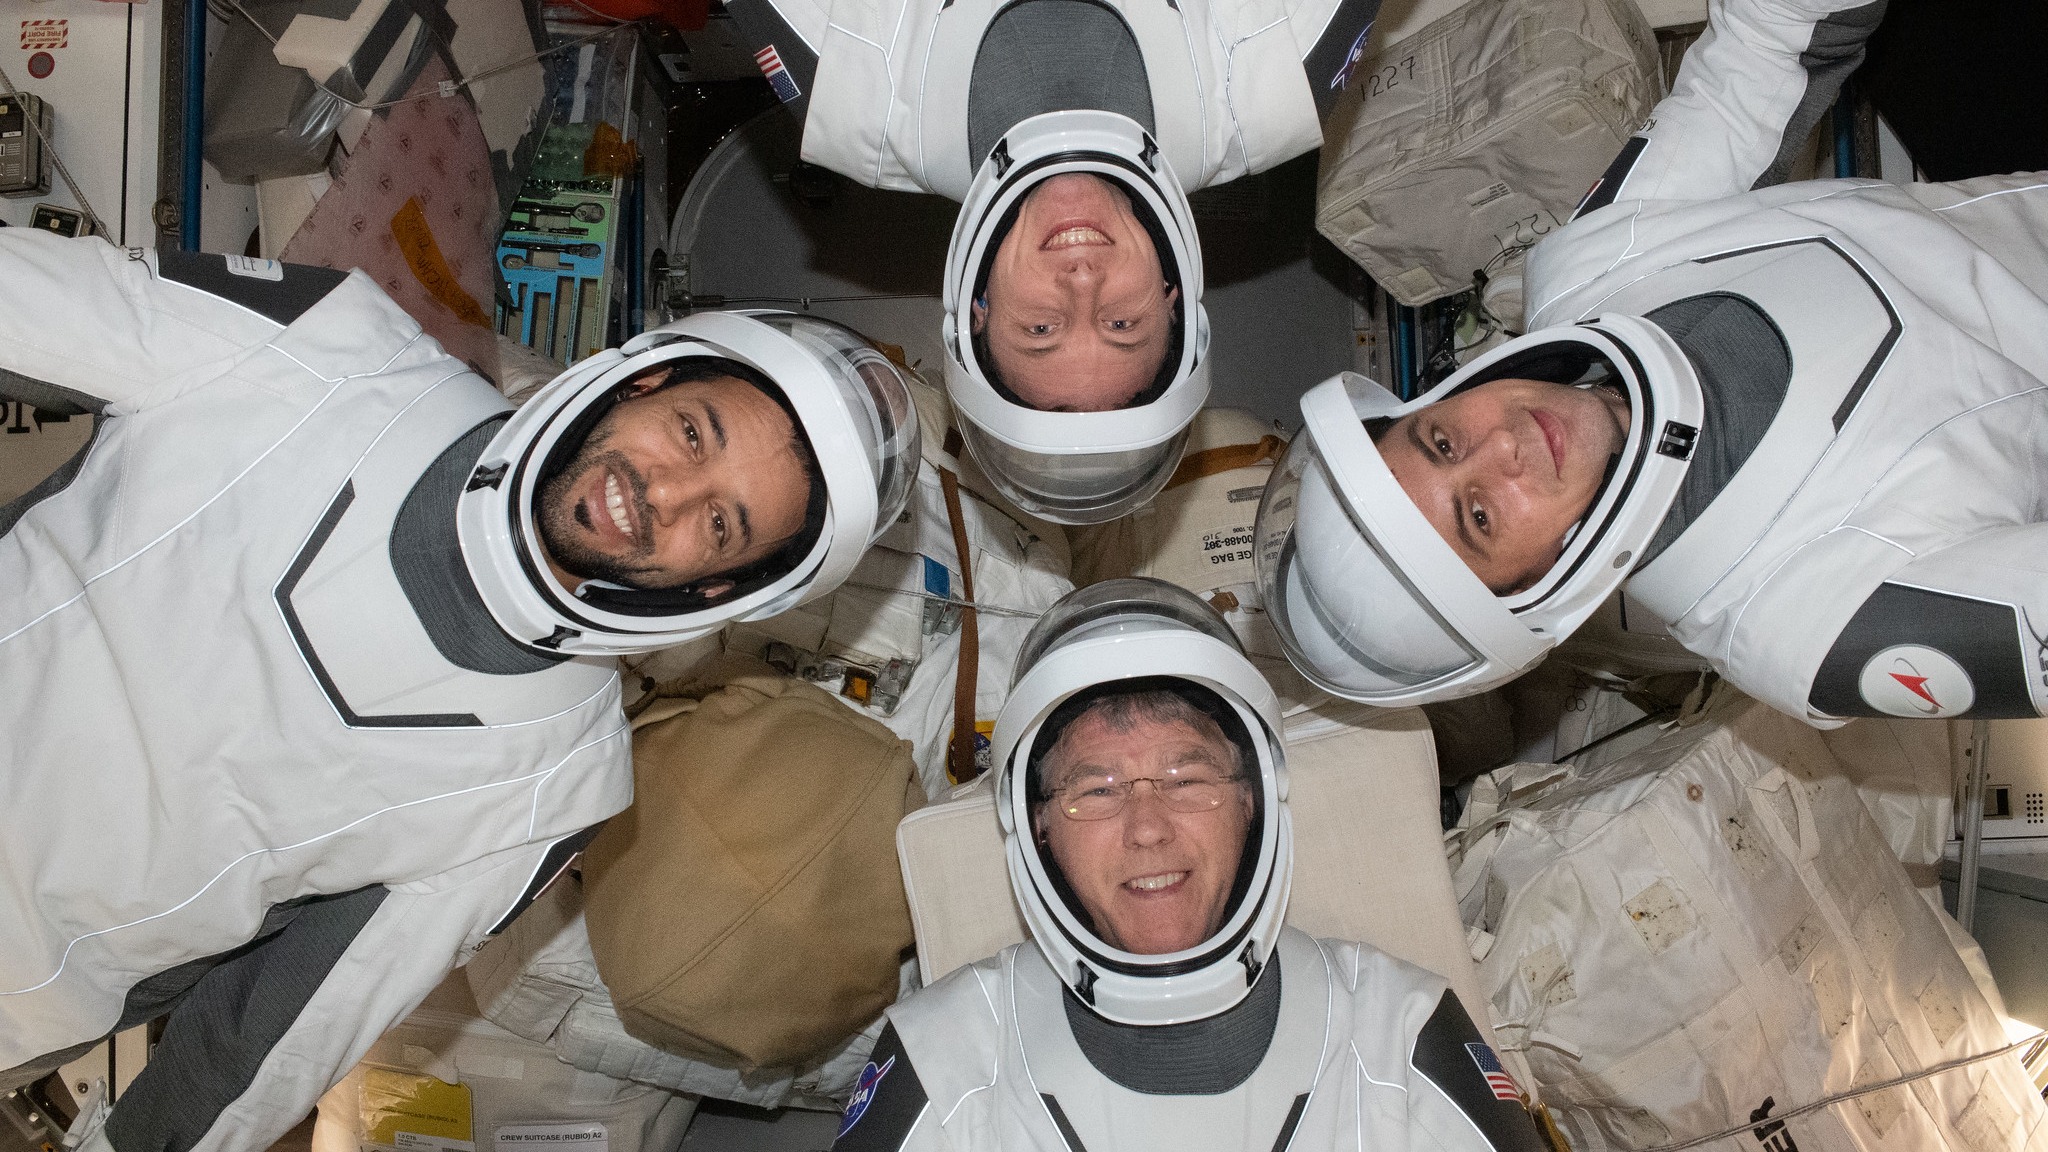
(1452, 697), (2048, 1152)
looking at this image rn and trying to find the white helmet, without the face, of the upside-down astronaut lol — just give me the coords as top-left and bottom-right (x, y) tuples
(942, 111), (1208, 525)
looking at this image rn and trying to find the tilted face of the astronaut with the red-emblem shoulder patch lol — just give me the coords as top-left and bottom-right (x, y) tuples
(1376, 379), (1628, 594)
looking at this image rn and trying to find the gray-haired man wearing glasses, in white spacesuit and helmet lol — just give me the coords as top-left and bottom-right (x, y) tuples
(834, 580), (1540, 1152)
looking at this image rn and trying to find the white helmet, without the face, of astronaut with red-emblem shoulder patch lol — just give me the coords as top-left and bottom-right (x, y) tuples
(1253, 316), (1702, 707)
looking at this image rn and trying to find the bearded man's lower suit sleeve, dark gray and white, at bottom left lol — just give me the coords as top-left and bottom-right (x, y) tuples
(82, 836), (578, 1152)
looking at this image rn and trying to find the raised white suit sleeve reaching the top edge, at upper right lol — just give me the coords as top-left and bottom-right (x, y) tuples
(1579, 0), (1884, 215)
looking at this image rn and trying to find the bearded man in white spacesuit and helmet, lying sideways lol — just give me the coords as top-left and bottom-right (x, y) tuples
(0, 230), (918, 1152)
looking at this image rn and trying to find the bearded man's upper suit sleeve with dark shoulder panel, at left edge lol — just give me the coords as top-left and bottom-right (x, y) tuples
(0, 228), (319, 414)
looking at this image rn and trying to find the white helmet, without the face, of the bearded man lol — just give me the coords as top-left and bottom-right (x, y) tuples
(457, 312), (918, 654)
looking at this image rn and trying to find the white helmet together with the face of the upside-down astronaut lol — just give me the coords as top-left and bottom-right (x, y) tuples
(944, 111), (1208, 525)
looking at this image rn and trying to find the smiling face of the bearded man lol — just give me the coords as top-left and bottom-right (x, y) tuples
(537, 369), (809, 594)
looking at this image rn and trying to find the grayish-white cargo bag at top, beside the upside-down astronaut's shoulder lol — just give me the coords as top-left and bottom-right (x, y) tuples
(1315, 0), (1659, 305)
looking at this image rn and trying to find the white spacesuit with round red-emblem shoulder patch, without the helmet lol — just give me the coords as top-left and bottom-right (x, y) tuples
(1526, 0), (2048, 724)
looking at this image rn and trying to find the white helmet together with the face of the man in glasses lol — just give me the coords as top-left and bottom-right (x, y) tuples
(995, 578), (1292, 1004)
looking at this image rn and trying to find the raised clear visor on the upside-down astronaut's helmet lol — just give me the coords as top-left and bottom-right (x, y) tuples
(961, 420), (1188, 525)
